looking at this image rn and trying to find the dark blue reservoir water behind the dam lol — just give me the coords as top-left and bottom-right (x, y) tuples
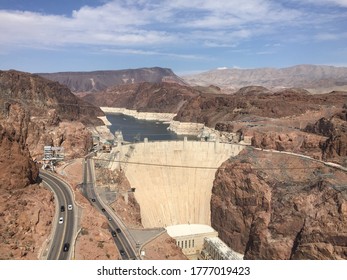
(106, 114), (196, 142)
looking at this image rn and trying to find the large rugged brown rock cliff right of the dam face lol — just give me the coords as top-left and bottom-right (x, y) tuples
(211, 150), (347, 259)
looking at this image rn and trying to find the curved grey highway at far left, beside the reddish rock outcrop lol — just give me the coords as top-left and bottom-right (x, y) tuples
(40, 170), (76, 260)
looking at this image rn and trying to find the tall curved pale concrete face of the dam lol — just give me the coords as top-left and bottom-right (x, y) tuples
(121, 141), (244, 228)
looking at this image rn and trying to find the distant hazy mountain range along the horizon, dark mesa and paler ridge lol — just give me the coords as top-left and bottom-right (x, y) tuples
(38, 65), (347, 93)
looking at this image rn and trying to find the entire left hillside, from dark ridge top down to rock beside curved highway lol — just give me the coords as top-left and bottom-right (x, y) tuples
(0, 71), (103, 259)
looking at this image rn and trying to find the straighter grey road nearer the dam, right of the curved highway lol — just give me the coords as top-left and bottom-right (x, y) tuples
(83, 157), (137, 260)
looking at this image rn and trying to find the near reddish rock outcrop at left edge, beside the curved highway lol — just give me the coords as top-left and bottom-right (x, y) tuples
(0, 104), (54, 259)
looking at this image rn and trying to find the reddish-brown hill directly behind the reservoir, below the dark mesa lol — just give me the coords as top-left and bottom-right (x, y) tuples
(83, 82), (200, 113)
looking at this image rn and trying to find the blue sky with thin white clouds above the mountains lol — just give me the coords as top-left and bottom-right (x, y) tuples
(0, 0), (347, 75)
